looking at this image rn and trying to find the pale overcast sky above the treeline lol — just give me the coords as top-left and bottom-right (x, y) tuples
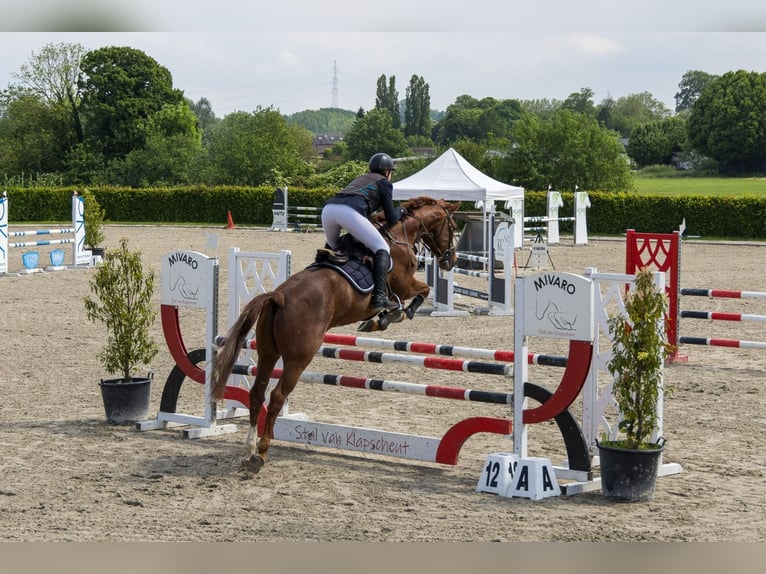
(0, 0), (766, 117)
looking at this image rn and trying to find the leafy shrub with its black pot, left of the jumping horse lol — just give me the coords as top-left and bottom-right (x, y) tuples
(84, 238), (158, 424)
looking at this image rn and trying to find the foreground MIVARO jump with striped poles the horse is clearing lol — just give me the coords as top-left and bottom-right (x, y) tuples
(137, 249), (680, 494)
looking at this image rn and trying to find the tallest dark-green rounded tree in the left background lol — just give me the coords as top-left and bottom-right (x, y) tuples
(78, 47), (183, 162)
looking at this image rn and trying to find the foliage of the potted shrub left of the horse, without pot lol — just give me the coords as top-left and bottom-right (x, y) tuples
(83, 237), (159, 382)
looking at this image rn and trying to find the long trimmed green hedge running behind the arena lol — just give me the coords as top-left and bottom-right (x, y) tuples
(5, 186), (766, 239)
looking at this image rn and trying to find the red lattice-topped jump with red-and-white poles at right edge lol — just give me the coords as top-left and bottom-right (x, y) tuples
(625, 229), (766, 362)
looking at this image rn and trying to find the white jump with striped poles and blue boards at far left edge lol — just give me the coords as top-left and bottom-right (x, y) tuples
(0, 192), (92, 275)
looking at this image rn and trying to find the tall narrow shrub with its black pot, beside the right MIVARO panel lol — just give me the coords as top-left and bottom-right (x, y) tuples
(597, 268), (672, 501)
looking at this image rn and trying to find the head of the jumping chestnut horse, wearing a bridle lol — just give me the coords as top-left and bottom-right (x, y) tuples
(404, 197), (460, 271)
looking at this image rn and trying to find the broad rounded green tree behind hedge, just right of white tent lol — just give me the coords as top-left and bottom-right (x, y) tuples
(496, 109), (632, 195)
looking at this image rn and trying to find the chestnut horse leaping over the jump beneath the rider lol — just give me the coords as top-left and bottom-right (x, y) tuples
(212, 197), (460, 472)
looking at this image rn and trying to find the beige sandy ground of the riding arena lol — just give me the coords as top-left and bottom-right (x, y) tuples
(0, 225), (766, 542)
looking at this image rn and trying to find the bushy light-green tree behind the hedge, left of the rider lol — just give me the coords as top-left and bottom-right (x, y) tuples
(197, 106), (310, 186)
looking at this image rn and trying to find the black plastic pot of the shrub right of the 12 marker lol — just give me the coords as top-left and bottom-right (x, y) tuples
(596, 441), (665, 502)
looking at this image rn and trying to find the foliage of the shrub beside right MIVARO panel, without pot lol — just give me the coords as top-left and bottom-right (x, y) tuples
(607, 268), (672, 450)
